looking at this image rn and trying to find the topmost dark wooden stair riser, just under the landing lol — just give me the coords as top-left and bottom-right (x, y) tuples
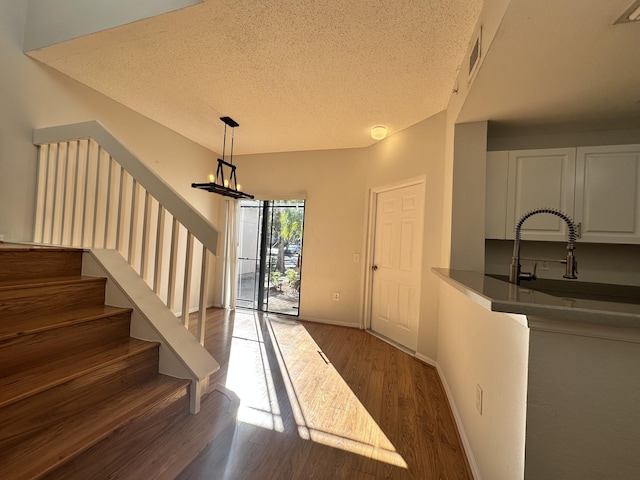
(0, 249), (82, 281)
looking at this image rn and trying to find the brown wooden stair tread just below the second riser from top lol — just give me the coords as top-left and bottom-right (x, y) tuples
(0, 305), (131, 341)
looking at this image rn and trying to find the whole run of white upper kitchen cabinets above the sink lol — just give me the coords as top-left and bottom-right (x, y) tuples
(485, 145), (640, 243)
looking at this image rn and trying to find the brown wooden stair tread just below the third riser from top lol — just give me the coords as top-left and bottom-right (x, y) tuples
(0, 338), (159, 408)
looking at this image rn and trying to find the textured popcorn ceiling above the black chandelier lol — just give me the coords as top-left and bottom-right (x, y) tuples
(30, 0), (482, 153)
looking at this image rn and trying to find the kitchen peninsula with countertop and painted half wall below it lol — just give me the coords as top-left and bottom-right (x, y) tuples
(432, 268), (640, 480)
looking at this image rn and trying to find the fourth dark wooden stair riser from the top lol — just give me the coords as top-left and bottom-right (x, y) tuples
(0, 347), (158, 446)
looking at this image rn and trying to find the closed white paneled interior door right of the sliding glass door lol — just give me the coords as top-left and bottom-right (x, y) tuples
(371, 183), (424, 351)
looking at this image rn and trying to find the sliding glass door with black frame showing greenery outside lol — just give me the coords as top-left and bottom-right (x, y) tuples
(237, 200), (304, 316)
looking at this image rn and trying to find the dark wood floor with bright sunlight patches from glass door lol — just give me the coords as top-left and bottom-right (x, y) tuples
(178, 309), (472, 480)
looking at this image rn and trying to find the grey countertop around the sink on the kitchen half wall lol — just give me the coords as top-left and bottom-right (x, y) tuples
(432, 268), (640, 329)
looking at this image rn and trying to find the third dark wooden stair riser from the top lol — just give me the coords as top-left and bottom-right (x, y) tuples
(0, 313), (131, 375)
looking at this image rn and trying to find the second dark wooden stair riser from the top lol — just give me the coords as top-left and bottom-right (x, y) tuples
(0, 278), (106, 319)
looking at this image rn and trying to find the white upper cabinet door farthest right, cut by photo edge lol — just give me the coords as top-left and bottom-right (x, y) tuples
(575, 145), (640, 243)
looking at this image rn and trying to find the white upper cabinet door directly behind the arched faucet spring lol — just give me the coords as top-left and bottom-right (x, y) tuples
(506, 148), (576, 241)
